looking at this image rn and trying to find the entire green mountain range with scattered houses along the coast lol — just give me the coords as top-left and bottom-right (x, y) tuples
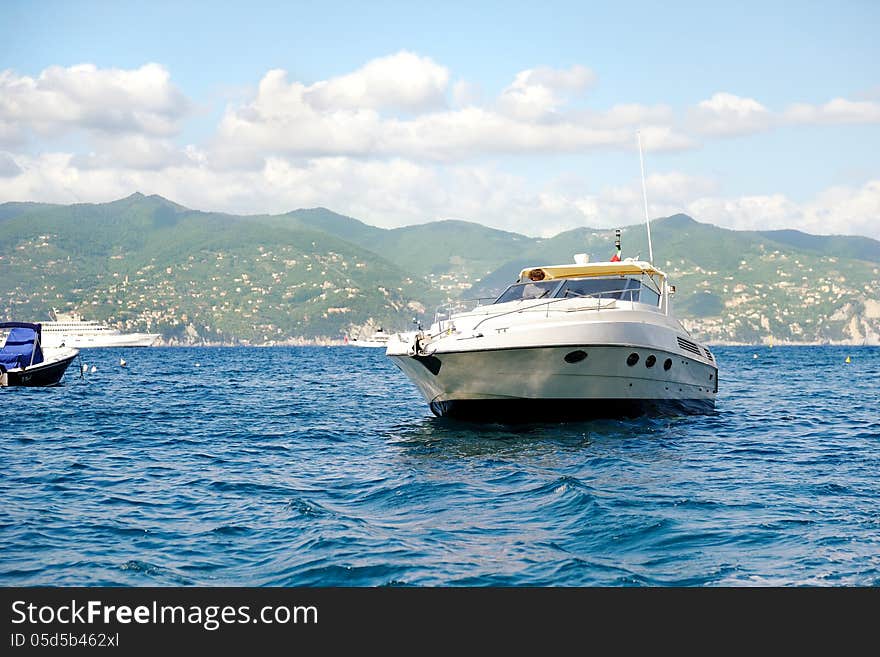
(0, 194), (880, 344)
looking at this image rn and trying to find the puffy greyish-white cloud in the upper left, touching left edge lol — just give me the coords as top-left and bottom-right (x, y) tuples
(0, 64), (189, 141)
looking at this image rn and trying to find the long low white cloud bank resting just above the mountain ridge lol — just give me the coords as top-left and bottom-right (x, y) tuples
(0, 151), (880, 239)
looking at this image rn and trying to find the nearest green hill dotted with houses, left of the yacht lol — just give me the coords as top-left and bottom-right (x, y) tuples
(0, 194), (439, 343)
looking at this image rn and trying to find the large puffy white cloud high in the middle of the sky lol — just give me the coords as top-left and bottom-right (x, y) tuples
(211, 56), (693, 169)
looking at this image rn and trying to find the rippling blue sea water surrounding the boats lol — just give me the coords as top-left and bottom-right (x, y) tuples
(0, 347), (880, 587)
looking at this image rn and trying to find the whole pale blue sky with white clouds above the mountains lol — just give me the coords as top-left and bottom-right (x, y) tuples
(0, 0), (880, 239)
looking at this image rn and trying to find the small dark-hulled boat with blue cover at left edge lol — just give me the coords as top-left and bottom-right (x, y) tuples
(0, 322), (79, 386)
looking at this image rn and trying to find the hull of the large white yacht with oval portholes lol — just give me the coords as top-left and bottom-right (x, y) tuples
(388, 344), (718, 419)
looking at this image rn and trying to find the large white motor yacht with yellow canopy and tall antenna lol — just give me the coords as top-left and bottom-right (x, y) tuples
(385, 133), (718, 420)
